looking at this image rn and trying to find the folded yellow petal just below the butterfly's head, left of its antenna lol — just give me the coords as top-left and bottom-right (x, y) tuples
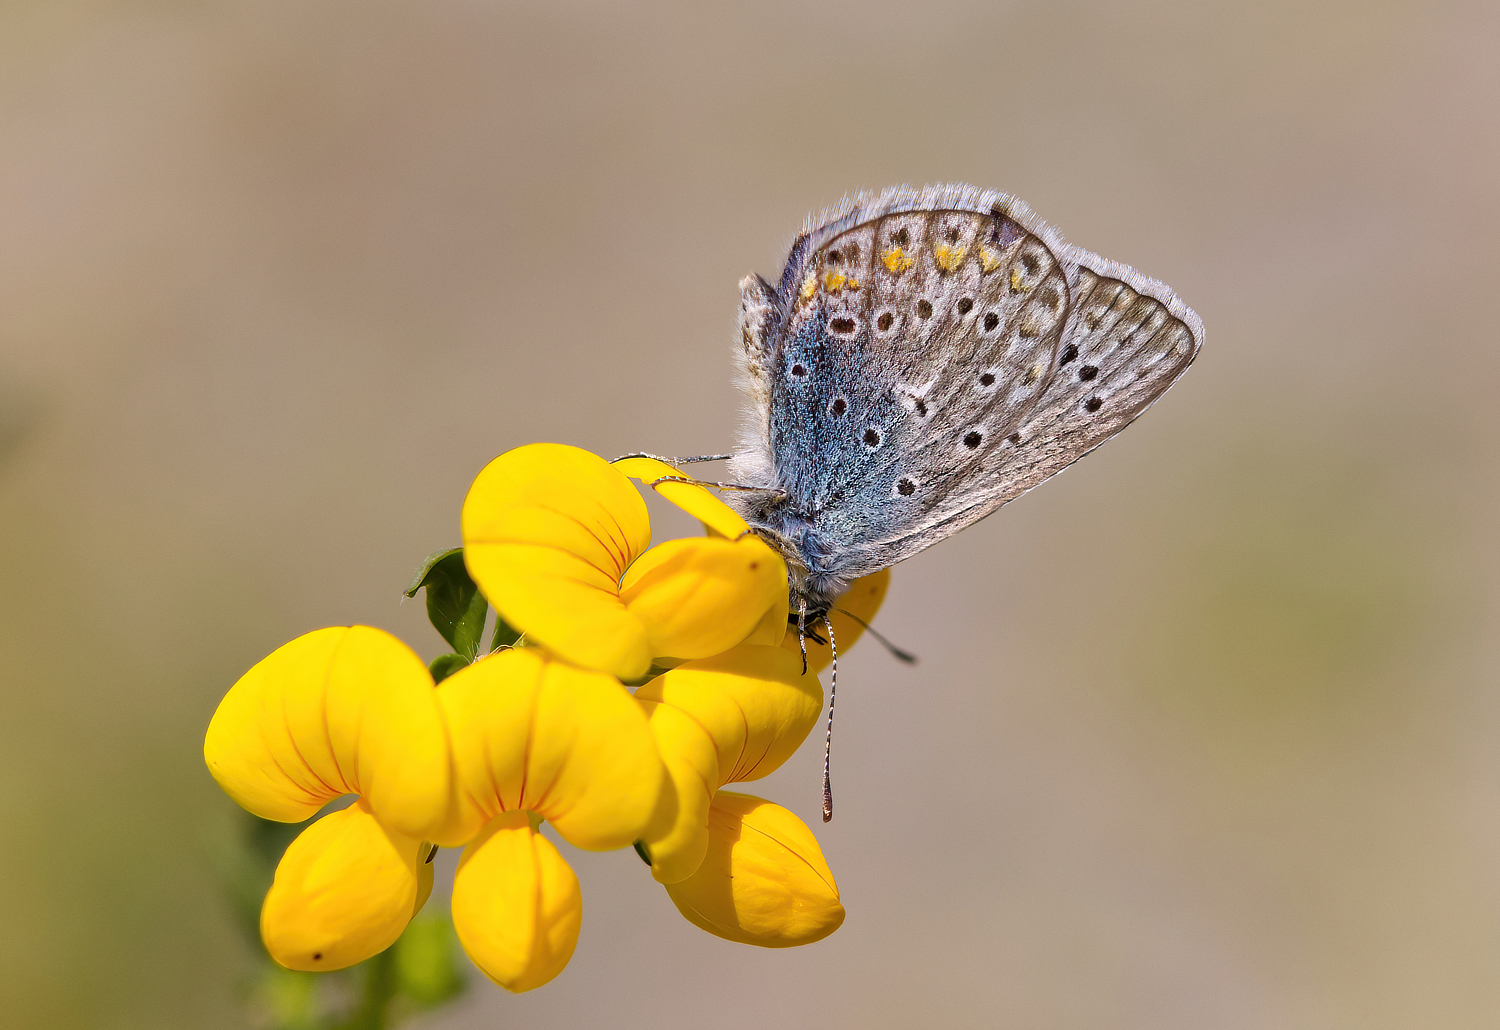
(636, 645), (824, 789)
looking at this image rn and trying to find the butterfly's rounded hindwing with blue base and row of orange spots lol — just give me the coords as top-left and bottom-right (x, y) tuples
(768, 203), (1068, 540)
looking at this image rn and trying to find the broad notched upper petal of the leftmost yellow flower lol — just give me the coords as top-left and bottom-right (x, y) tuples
(203, 625), (449, 838)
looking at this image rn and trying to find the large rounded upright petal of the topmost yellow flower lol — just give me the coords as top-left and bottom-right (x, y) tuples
(462, 444), (651, 679)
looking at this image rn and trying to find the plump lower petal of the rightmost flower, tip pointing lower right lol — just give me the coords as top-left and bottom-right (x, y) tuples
(666, 790), (845, 948)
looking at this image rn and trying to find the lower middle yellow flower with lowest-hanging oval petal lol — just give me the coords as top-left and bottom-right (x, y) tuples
(435, 648), (663, 991)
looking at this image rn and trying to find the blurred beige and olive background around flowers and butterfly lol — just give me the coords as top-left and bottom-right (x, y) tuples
(0, 0), (1500, 1030)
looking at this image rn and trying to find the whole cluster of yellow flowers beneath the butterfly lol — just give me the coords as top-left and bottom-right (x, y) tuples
(204, 444), (885, 991)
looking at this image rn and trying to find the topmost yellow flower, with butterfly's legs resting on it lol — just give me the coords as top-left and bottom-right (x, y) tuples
(462, 444), (786, 679)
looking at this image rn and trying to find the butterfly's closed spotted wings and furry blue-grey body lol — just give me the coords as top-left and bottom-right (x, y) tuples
(729, 186), (1203, 612)
